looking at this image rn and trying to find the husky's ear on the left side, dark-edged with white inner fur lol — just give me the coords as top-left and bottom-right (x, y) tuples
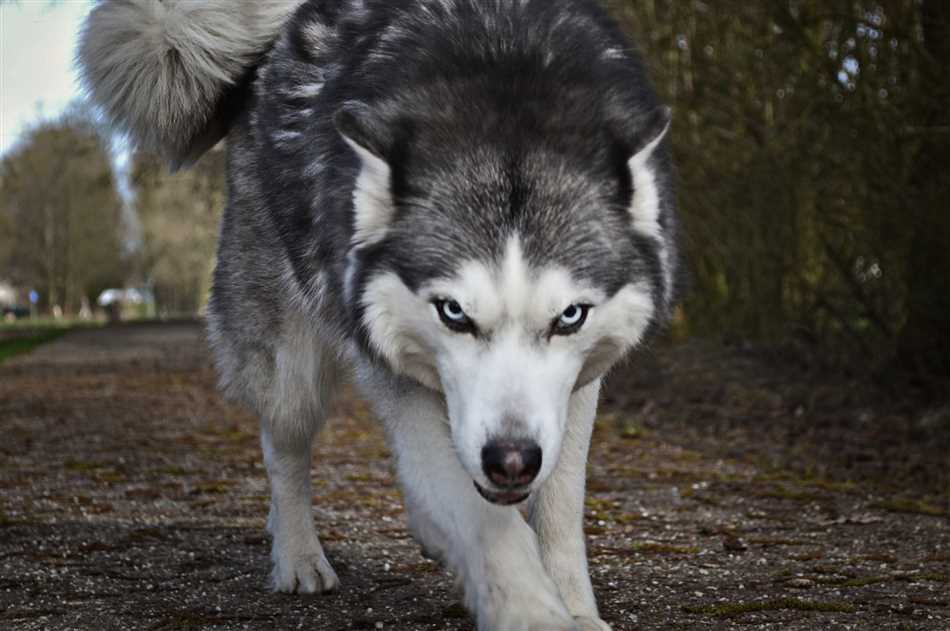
(333, 102), (395, 247)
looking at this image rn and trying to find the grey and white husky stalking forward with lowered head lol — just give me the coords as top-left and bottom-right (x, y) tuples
(80, 0), (676, 631)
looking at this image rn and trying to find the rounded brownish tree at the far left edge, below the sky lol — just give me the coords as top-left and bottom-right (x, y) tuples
(0, 110), (125, 313)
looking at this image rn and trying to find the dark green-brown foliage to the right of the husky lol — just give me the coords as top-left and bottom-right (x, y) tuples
(609, 0), (950, 371)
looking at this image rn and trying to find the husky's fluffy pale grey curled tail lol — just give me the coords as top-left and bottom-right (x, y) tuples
(78, 0), (303, 168)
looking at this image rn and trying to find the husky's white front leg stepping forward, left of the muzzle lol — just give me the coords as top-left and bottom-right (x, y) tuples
(366, 379), (578, 631)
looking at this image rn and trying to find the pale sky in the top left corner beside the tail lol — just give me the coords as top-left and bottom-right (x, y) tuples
(0, 0), (93, 155)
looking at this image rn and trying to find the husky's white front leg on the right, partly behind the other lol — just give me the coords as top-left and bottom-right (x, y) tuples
(530, 381), (610, 631)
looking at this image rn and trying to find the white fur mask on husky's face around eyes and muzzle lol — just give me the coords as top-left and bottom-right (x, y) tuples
(361, 238), (653, 488)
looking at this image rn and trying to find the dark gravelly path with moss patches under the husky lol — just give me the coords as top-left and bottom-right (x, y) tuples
(0, 323), (950, 630)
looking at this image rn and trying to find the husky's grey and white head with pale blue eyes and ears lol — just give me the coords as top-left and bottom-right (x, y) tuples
(337, 99), (671, 504)
